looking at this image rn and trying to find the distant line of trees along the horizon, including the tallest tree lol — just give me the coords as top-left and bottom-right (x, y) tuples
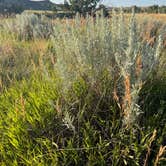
(52, 0), (166, 15)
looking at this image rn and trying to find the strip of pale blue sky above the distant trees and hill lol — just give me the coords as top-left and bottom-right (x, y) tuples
(48, 0), (166, 6)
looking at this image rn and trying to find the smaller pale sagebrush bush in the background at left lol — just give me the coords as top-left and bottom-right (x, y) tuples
(4, 12), (52, 40)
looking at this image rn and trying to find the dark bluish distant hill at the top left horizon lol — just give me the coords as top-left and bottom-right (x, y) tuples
(0, 0), (55, 13)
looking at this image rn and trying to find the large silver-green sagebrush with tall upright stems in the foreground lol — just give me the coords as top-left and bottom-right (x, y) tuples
(52, 11), (165, 125)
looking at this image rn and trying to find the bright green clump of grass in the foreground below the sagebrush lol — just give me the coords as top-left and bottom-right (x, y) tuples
(0, 73), (161, 165)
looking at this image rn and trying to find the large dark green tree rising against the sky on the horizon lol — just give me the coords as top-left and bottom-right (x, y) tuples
(68, 0), (100, 15)
